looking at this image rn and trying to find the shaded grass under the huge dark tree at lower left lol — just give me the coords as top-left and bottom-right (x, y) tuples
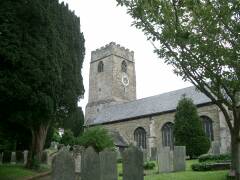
(0, 164), (49, 180)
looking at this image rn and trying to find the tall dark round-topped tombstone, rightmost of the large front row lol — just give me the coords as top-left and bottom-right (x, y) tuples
(123, 146), (144, 180)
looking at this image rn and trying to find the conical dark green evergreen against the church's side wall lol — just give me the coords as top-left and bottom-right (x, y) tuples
(173, 96), (210, 158)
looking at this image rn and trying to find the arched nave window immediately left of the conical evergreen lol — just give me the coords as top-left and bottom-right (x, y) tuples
(162, 122), (173, 149)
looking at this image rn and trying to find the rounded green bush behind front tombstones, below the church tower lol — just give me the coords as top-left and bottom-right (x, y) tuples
(77, 127), (114, 152)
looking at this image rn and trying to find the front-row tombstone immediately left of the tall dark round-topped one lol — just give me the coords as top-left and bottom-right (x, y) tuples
(99, 150), (118, 180)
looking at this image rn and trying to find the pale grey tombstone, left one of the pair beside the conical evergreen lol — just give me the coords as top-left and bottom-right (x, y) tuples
(158, 147), (173, 173)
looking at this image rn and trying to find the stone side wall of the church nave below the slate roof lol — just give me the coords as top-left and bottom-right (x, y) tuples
(103, 105), (229, 157)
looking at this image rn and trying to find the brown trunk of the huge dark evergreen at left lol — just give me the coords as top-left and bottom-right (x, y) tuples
(26, 124), (49, 168)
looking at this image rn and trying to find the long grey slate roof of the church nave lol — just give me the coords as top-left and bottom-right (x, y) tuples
(89, 86), (211, 125)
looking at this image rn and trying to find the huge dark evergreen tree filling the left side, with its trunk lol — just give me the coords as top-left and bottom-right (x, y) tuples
(0, 0), (85, 167)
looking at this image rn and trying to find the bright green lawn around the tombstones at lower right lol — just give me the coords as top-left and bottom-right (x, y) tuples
(118, 160), (228, 180)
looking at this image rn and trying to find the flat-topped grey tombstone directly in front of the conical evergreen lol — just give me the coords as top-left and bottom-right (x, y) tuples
(173, 146), (186, 171)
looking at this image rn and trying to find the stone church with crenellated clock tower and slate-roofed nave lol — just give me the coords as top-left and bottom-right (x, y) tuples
(85, 42), (230, 157)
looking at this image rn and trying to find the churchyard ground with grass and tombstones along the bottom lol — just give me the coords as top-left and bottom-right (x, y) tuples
(0, 146), (228, 180)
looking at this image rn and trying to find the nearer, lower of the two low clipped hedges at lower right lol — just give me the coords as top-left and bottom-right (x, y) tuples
(191, 162), (230, 171)
